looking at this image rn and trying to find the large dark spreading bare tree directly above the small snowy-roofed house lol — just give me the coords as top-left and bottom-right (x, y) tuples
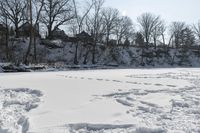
(42, 0), (75, 38)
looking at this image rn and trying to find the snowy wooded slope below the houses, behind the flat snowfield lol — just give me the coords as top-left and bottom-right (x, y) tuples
(0, 39), (200, 67)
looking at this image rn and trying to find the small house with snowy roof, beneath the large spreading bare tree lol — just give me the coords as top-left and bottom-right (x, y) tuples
(51, 28), (68, 40)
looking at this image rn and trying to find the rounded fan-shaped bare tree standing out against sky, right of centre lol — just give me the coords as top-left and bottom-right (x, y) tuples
(137, 13), (161, 46)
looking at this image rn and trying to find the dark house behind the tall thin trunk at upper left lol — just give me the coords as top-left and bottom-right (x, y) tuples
(18, 22), (40, 37)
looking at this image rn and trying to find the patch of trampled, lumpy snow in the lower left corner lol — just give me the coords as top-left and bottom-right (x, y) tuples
(0, 88), (42, 133)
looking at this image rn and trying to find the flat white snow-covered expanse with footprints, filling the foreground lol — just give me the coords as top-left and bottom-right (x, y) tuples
(0, 68), (200, 133)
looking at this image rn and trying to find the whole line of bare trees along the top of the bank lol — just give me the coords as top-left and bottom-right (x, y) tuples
(0, 0), (200, 64)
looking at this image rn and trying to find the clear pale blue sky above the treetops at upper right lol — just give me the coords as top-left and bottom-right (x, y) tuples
(105, 0), (200, 24)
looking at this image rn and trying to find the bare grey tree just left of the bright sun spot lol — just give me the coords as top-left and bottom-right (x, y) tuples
(102, 8), (119, 45)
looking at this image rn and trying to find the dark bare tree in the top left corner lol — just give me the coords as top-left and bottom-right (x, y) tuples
(0, 0), (26, 37)
